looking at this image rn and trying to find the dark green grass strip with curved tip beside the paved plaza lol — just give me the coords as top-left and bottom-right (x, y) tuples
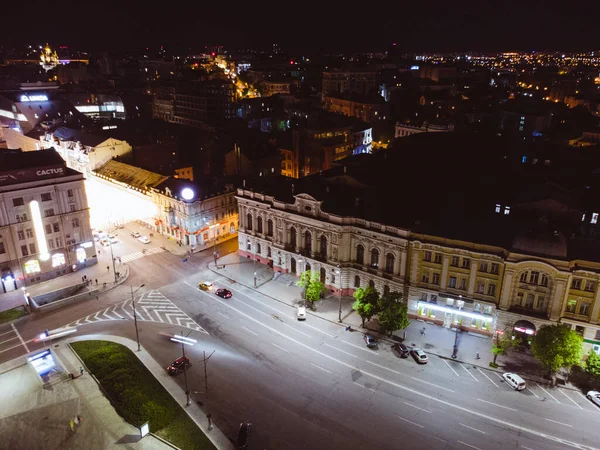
(71, 341), (216, 450)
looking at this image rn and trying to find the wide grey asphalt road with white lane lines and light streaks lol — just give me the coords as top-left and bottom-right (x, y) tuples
(0, 232), (600, 450)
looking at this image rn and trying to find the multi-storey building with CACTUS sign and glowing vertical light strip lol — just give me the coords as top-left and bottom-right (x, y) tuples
(0, 149), (97, 292)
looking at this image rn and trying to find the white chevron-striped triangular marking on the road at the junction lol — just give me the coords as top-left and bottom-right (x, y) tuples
(63, 290), (208, 334)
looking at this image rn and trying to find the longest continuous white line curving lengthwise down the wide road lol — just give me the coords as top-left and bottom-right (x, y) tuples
(207, 299), (598, 450)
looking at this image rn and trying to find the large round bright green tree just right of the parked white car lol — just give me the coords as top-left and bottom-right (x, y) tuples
(531, 324), (583, 384)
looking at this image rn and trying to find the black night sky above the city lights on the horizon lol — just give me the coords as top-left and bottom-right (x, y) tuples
(0, 0), (600, 52)
